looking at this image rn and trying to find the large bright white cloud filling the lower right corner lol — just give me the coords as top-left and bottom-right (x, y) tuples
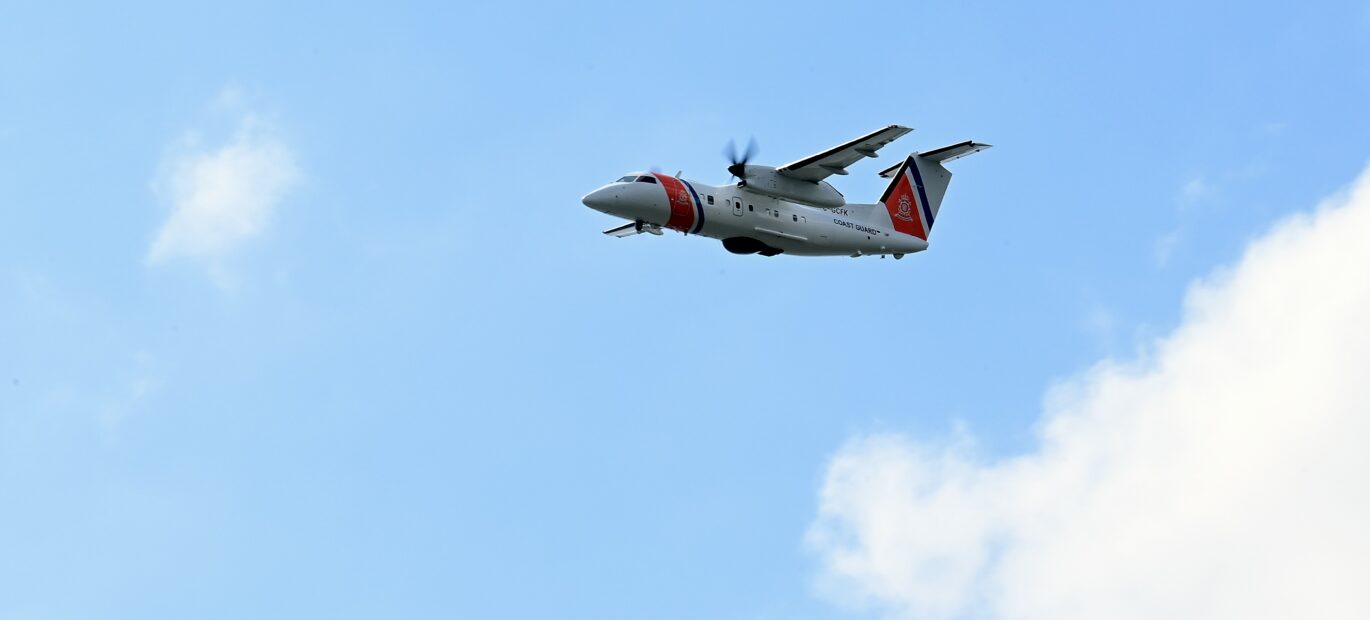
(808, 162), (1370, 620)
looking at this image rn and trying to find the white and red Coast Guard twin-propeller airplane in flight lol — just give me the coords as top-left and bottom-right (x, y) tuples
(581, 125), (989, 259)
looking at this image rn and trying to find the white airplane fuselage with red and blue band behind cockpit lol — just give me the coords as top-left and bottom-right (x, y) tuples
(584, 172), (927, 257)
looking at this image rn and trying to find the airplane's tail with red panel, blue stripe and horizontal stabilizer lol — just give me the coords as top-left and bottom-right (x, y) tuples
(880, 141), (989, 241)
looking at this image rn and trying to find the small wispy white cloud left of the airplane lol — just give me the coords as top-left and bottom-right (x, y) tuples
(148, 116), (299, 266)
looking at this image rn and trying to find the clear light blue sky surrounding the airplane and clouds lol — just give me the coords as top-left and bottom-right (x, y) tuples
(0, 1), (1370, 619)
